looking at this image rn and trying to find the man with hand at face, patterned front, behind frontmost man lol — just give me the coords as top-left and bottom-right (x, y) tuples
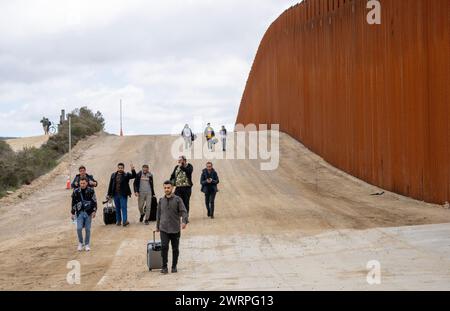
(170, 156), (194, 214)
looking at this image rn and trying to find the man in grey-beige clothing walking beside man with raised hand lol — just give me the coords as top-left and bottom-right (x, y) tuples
(133, 164), (155, 225)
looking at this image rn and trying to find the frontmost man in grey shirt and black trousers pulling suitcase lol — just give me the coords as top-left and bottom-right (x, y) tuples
(156, 181), (189, 274)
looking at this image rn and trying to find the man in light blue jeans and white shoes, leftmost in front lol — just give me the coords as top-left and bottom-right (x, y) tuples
(71, 177), (97, 252)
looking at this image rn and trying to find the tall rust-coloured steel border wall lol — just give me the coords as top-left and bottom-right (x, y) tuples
(237, 0), (450, 203)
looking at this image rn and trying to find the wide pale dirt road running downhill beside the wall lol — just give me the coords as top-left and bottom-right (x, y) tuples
(0, 135), (450, 290)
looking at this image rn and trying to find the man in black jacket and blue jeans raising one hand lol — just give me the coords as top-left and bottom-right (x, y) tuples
(108, 163), (136, 227)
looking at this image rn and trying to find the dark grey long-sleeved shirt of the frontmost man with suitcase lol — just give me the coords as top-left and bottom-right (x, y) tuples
(156, 194), (189, 233)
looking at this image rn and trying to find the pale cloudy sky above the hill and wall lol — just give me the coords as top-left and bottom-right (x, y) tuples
(0, 0), (299, 136)
